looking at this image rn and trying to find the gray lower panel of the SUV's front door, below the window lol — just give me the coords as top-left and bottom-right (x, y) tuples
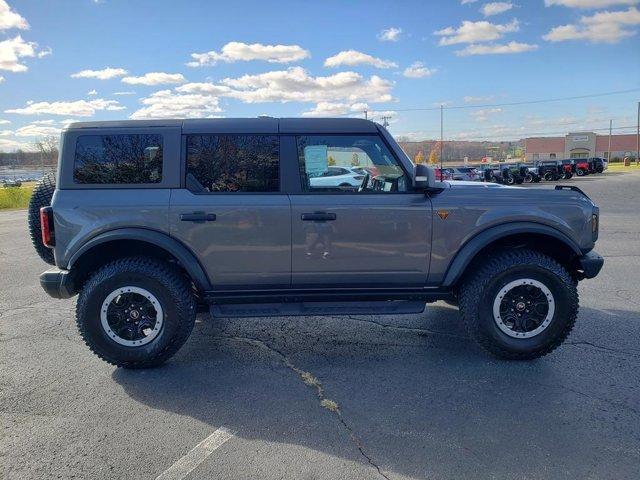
(291, 193), (431, 287)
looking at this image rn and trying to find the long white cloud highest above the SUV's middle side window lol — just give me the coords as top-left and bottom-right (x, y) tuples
(187, 42), (309, 67)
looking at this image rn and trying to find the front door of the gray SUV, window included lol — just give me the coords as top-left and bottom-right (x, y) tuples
(291, 135), (431, 288)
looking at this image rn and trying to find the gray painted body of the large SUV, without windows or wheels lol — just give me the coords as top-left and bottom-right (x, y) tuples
(52, 118), (595, 300)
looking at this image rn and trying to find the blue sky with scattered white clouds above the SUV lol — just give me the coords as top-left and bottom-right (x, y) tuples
(0, 0), (640, 150)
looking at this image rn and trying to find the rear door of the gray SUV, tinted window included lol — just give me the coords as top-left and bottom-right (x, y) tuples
(169, 126), (291, 289)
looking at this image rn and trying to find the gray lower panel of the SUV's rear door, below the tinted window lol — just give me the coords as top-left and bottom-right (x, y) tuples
(169, 189), (291, 289)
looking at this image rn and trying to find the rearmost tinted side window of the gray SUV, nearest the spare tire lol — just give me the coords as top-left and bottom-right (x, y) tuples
(73, 134), (162, 184)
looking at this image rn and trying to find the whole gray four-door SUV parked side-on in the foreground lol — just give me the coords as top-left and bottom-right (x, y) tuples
(30, 118), (603, 368)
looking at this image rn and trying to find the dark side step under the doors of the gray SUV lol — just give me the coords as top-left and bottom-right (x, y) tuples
(210, 300), (425, 318)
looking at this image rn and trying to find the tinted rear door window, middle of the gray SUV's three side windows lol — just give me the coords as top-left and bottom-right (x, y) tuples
(186, 135), (280, 193)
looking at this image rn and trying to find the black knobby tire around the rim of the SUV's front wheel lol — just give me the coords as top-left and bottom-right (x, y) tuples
(458, 249), (578, 360)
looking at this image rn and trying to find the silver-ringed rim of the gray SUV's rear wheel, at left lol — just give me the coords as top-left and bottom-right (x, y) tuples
(100, 286), (164, 347)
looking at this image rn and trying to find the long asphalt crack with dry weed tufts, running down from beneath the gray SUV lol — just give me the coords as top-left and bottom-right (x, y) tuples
(213, 335), (391, 480)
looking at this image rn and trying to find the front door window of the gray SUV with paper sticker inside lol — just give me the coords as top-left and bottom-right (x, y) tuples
(296, 135), (409, 193)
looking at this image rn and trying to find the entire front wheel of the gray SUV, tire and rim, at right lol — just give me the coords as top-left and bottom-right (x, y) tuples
(459, 249), (578, 360)
